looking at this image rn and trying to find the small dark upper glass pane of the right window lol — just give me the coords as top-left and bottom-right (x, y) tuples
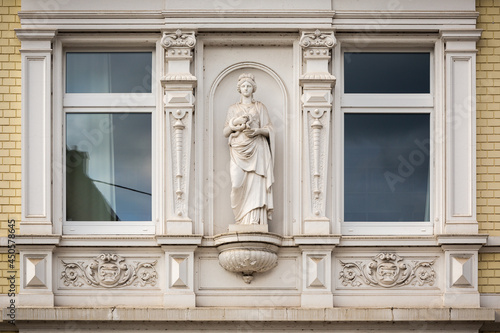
(344, 52), (430, 94)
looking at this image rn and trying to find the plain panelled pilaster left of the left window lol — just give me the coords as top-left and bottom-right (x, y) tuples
(16, 30), (57, 235)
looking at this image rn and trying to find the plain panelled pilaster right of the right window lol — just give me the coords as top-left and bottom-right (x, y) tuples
(441, 30), (481, 234)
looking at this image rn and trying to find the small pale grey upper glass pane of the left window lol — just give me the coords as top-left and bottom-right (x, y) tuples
(66, 52), (152, 93)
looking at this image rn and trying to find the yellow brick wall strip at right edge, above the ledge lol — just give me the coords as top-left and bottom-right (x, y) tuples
(476, 0), (500, 236)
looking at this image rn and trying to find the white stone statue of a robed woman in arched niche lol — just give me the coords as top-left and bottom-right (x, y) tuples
(224, 74), (274, 225)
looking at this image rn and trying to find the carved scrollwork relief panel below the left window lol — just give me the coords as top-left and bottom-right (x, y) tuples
(61, 253), (158, 288)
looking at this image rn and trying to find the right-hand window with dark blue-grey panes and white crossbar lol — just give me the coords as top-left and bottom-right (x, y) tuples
(341, 50), (433, 235)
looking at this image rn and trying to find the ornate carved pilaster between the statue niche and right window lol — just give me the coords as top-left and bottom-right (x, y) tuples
(300, 30), (336, 234)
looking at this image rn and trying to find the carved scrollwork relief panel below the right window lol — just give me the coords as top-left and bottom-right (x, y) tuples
(340, 252), (436, 288)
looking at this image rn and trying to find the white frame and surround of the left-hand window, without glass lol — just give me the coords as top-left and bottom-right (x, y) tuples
(53, 34), (163, 235)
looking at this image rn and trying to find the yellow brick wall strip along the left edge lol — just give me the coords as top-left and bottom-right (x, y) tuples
(0, 0), (21, 294)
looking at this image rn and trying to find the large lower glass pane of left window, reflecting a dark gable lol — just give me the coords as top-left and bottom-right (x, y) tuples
(66, 113), (151, 221)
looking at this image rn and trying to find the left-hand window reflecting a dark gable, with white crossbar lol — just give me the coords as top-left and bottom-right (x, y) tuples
(63, 50), (155, 234)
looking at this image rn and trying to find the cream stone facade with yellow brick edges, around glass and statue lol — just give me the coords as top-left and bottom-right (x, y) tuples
(0, 0), (500, 332)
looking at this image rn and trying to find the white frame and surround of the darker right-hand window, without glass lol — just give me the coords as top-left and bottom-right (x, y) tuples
(333, 34), (444, 236)
